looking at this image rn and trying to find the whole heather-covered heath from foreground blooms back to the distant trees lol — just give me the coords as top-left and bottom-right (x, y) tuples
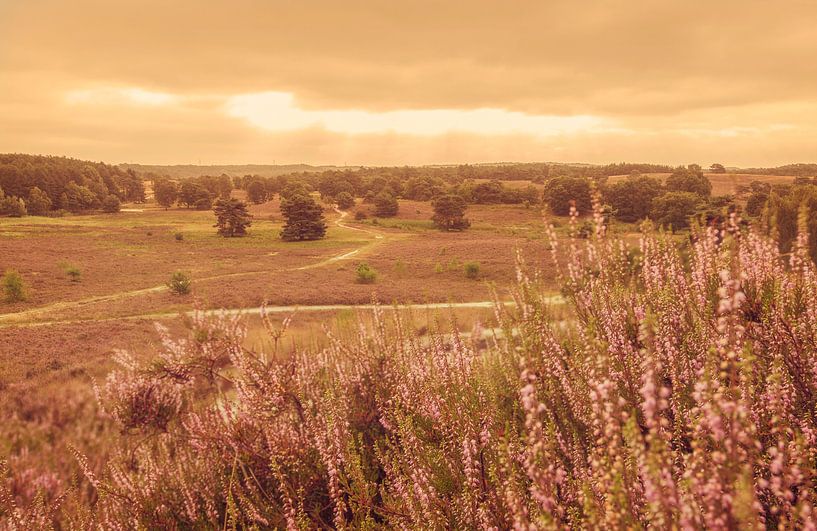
(0, 170), (817, 529)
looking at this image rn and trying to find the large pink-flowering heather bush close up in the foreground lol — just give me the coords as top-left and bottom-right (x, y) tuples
(47, 214), (817, 529)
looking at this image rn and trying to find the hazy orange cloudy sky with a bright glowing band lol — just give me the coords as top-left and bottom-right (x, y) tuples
(0, 0), (817, 167)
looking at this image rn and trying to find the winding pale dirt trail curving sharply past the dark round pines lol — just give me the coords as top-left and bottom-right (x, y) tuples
(0, 207), (400, 327)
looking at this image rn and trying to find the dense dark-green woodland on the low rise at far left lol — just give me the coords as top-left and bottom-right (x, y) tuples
(0, 154), (145, 216)
